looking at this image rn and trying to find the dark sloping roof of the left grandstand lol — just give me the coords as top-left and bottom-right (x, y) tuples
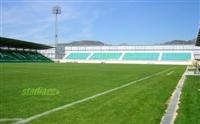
(0, 37), (53, 50)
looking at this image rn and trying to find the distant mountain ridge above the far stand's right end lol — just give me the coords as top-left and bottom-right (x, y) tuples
(161, 39), (195, 45)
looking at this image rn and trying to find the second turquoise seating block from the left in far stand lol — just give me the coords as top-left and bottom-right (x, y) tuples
(90, 53), (122, 60)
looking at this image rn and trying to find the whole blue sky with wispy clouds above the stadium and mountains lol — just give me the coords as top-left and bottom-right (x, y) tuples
(1, 0), (200, 45)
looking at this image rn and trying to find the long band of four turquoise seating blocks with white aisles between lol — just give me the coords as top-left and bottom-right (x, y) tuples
(64, 51), (192, 61)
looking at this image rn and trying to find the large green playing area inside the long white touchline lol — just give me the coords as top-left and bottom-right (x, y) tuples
(0, 64), (175, 118)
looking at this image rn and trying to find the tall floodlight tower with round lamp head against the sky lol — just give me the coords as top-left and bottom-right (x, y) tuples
(52, 6), (61, 59)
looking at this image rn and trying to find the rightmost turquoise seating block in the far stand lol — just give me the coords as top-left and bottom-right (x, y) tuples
(162, 53), (191, 61)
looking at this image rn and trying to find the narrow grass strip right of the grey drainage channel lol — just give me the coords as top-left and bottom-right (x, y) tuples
(175, 76), (200, 124)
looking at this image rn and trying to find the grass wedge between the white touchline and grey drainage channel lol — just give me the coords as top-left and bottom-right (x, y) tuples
(32, 66), (185, 124)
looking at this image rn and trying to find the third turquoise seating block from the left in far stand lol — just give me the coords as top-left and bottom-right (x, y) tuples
(123, 53), (160, 60)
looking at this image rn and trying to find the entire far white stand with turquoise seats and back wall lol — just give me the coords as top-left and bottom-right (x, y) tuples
(60, 45), (200, 65)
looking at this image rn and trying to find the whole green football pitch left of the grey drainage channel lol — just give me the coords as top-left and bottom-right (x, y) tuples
(0, 63), (186, 124)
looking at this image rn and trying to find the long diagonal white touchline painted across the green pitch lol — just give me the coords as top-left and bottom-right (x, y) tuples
(15, 67), (176, 124)
